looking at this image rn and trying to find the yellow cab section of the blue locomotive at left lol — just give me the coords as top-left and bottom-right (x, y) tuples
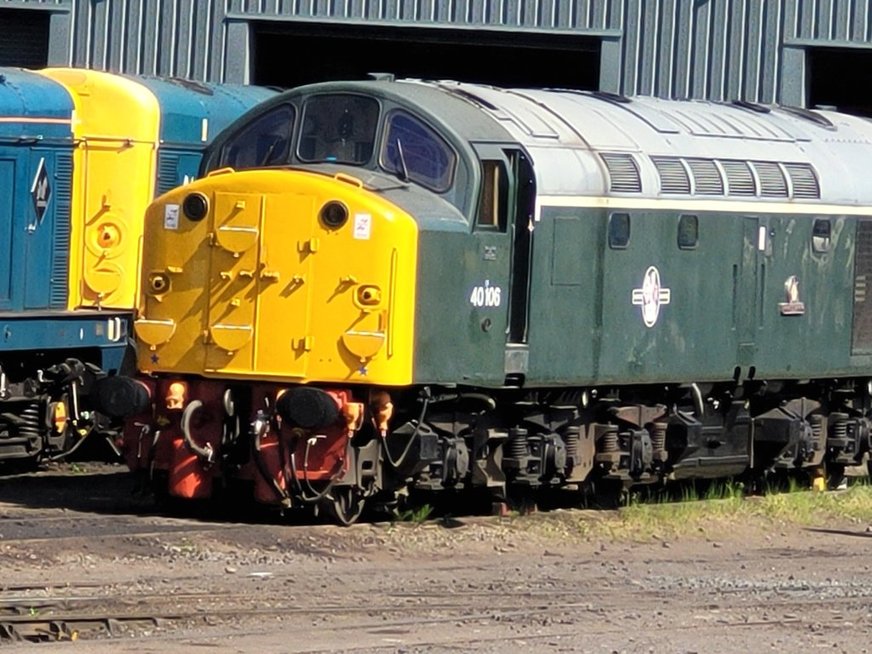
(41, 68), (161, 309)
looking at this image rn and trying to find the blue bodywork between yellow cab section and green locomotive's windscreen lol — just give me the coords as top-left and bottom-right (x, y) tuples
(133, 77), (275, 195)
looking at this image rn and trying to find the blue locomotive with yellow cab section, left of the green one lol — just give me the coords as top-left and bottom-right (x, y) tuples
(0, 68), (271, 460)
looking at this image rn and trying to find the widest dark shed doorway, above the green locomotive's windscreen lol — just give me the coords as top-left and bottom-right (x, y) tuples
(252, 22), (600, 90)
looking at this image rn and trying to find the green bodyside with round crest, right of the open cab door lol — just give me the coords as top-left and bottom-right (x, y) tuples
(526, 208), (868, 386)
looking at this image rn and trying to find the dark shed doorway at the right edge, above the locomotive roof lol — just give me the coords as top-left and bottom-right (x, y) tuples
(806, 48), (872, 116)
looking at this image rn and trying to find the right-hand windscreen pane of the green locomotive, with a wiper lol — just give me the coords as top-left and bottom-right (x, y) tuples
(379, 111), (457, 193)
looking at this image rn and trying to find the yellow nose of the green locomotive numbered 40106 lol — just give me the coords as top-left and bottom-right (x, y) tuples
(136, 170), (417, 385)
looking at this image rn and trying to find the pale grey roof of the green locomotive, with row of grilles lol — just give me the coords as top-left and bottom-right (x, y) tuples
(209, 80), (872, 205)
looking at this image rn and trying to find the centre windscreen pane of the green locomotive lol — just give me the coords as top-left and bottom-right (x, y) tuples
(297, 94), (379, 165)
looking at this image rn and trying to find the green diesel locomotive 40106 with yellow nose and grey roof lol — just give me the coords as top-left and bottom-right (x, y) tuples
(103, 79), (872, 522)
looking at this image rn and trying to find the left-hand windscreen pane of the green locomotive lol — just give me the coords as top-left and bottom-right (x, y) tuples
(219, 104), (296, 170)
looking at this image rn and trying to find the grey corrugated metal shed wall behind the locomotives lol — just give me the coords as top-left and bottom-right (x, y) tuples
(10, 0), (872, 102)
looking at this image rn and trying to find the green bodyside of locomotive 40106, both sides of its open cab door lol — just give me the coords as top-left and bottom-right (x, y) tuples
(414, 207), (870, 387)
